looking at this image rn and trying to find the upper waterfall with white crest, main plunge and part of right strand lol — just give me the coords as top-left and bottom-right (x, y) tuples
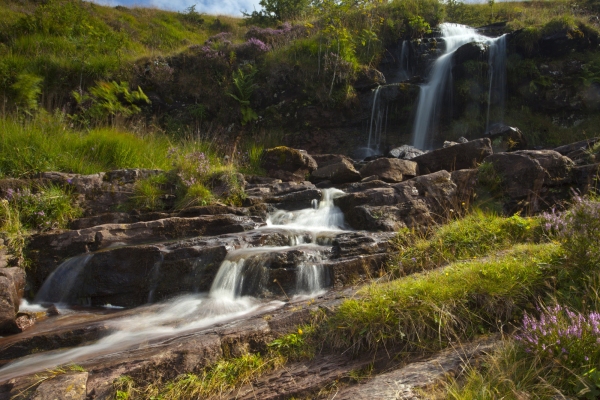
(413, 23), (506, 150)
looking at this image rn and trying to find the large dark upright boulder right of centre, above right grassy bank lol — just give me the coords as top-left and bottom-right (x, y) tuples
(484, 153), (546, 215)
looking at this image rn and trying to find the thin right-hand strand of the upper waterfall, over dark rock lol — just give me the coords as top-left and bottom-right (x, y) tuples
(485, 35), (507, 133)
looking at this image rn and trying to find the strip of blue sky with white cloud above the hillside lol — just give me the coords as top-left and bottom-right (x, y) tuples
(92, 0), (260, 16)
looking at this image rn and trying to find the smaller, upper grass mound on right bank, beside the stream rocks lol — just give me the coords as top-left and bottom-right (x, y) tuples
(391, 210), (542, 275)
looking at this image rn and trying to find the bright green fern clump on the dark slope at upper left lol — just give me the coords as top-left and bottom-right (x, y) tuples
(73, 81), (150, 125)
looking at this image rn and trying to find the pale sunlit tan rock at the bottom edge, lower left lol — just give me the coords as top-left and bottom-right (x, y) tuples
(31, 372), (88, 400)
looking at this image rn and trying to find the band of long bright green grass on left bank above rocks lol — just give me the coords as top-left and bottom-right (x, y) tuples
(0, 114), (171, 177)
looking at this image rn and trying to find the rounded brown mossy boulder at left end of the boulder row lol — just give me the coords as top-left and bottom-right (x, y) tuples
(261, 146), (318, 182)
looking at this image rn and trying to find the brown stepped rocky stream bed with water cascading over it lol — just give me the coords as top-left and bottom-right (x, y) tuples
(0, 135), (600, 399)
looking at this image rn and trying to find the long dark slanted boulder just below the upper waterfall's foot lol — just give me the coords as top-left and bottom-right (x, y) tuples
(412, 138), (493, 174)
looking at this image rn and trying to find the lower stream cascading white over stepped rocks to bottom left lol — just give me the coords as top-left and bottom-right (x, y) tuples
(0, 189), (344, 382)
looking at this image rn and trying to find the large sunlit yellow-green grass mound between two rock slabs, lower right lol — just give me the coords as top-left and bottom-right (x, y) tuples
(322, 243), (561, 352)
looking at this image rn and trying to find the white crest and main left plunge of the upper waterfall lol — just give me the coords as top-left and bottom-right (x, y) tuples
(413, 23), (506, 150)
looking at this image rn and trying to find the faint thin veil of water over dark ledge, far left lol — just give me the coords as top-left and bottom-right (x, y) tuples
(34, 253), (93, 303)
